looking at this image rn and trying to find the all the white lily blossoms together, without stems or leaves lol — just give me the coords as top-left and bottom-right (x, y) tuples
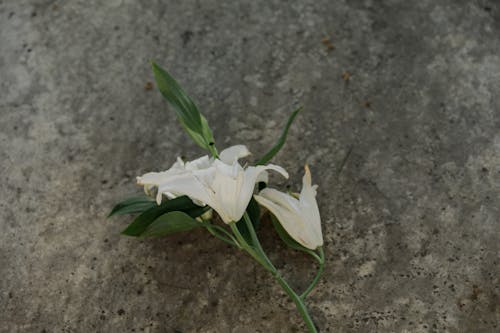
(137, 145), (323, 250)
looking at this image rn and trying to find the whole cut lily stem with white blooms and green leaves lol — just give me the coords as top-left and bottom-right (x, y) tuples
(108, 62), (325, 333)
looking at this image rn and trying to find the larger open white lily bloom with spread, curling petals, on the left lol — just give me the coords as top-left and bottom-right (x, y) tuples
(137, 145), (288, 223)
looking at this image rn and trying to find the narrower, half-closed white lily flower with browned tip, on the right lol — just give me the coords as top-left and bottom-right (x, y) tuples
(254, 165), (323, 250)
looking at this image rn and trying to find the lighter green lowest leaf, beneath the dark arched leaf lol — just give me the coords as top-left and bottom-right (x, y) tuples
(141, 211), (203, 237)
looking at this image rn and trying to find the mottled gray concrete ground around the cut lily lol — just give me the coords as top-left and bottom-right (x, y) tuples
(0, 0), (500, 333)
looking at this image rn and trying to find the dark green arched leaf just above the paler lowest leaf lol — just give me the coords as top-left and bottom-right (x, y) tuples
(122, 196), (208, 237)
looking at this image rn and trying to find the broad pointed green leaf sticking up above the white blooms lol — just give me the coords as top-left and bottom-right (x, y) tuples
(151, 62), (214, 150)
